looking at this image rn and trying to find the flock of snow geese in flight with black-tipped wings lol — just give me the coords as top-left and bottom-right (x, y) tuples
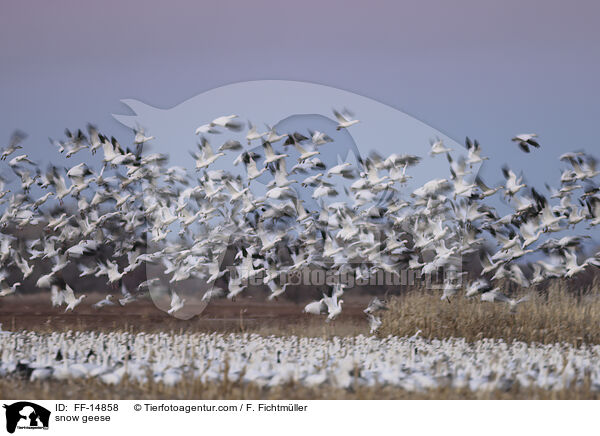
(0, 111), (600, 330)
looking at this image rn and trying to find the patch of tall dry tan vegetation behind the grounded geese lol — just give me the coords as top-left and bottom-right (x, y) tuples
(379, 281), (600, 345)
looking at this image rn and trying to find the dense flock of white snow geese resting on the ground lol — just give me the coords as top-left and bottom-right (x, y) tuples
(0, 331), (600, 392)
